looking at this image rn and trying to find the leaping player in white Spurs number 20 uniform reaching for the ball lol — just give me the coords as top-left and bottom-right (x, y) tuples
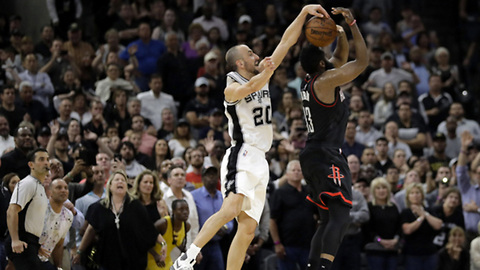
(170, 5), (329, 270)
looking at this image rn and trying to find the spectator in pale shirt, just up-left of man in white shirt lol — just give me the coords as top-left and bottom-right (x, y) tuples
(95, 63), (133, 104)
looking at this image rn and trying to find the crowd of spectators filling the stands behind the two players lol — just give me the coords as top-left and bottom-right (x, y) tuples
(0, 0), (480, 269)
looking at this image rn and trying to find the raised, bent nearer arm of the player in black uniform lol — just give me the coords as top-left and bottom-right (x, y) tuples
(317, 7), (369, 89)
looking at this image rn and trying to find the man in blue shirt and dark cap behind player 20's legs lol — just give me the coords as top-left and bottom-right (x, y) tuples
(192, 166), (234, 270)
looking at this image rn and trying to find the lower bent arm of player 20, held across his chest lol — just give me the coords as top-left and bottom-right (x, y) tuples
(224, 57), (277, 102)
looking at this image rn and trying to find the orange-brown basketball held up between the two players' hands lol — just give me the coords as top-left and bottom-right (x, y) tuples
(305, 17), (337, 47)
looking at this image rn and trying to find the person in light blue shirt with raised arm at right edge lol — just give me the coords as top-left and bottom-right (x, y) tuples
(455, 131), (480, 242)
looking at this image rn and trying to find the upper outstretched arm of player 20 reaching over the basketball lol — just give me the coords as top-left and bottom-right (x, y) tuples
(272, 5), (330, 68)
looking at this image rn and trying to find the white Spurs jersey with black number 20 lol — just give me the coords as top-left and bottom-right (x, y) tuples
(224, 71), (273, 152)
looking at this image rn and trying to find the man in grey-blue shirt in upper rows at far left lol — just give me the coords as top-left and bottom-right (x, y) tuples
(18, 53), (55, 108)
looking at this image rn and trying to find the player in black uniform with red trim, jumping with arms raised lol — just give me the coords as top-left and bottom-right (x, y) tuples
(300, 8), (368, 270)
